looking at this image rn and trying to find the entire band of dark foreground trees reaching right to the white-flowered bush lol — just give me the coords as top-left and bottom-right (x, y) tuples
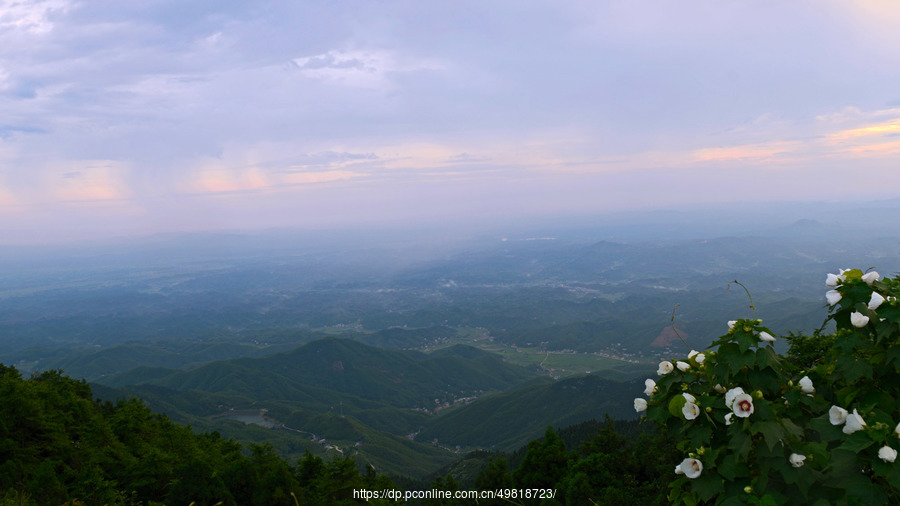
(0, 366), (674, 505)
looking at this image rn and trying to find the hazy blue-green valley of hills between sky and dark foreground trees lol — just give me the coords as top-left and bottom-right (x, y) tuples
(0, 212), (900, 479)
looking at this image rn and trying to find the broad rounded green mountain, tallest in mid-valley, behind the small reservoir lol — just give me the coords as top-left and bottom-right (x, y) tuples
(116, 338), (534, 409)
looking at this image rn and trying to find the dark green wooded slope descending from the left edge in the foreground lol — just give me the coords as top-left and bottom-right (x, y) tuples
(0, 365), (390, 505)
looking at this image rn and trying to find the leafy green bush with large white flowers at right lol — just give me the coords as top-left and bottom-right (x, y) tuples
(635, 269), (900, 505)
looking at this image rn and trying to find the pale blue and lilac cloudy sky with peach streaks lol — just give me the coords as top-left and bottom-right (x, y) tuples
(0, 0), (900, 243)
